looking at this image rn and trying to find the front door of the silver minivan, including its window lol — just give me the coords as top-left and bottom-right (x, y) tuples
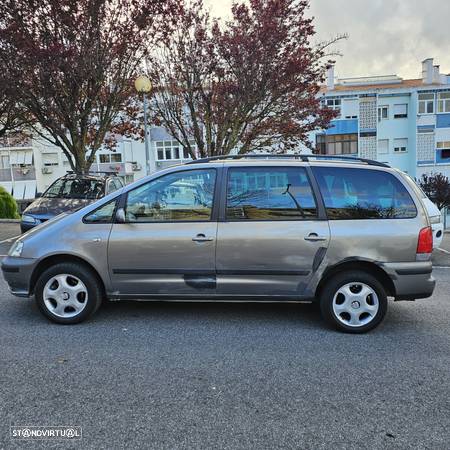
(108, 168), (218, 297)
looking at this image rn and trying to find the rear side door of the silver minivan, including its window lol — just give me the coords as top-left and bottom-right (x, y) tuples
(216, 163), (330, 298)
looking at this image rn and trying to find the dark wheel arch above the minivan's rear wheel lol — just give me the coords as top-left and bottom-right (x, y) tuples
(315, 259), (396, 298)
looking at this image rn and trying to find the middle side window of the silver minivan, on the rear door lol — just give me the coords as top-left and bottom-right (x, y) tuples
(226, 167), (317, 220)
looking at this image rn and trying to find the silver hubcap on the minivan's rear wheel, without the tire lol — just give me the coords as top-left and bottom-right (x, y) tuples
(333, 282), (380, 327)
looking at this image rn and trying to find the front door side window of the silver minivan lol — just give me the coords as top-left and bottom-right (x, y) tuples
(125, 169), (216, 222)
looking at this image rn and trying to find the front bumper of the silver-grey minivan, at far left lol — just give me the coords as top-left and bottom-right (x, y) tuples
(1, 256), (37, 297)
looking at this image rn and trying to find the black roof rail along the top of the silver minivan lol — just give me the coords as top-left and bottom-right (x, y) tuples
(185, 153), (390, 167)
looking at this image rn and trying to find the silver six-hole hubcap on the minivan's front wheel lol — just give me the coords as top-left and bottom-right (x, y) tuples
(43, 274), (88, 318)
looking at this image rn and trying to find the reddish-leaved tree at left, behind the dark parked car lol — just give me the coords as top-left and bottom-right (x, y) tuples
(0, 0), (173, 173)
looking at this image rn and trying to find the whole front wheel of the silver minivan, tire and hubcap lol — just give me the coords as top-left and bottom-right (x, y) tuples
(34, 263), (103, 325)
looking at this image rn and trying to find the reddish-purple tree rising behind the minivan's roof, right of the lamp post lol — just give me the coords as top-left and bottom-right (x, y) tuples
(148, 0), (342, 158)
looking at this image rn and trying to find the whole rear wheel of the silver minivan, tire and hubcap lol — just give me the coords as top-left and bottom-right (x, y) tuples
(319, 270), (388, 333)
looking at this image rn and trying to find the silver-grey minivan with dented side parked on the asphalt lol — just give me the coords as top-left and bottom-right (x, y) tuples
(2, 155), (435, 333)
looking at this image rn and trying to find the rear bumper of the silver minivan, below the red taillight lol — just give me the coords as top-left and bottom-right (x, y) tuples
(381, 261), (436, 300)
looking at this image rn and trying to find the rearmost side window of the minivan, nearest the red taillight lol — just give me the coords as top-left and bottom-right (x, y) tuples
(313, 167), (417, 220)
